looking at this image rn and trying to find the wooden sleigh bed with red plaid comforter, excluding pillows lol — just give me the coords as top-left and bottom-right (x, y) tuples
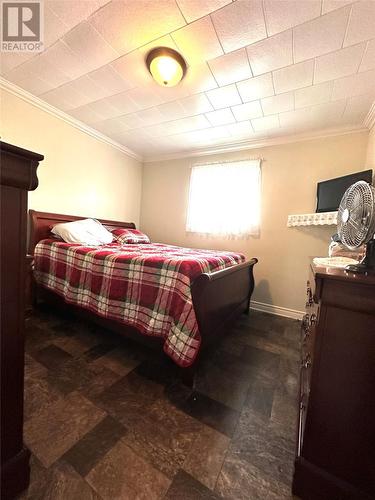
(29, 210), (257, 380)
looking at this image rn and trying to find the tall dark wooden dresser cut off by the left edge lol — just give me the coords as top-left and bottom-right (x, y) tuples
(0, 142), (43, 500)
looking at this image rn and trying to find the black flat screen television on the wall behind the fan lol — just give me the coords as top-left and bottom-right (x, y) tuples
(316, 170), (372, 212)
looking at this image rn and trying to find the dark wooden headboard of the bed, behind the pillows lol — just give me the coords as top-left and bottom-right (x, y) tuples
(28, 210), (135, 255)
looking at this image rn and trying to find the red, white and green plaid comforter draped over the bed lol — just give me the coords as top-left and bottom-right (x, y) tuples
(34, 239), (245, 367)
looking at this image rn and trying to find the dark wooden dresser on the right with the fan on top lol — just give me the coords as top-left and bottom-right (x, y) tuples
(293, 265), (375, 500)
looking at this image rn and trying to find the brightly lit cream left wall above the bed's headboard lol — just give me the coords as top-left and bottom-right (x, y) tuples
(1, 91), (142, 224)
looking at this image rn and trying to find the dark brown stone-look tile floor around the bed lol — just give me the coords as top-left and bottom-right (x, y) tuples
(21, 304), (299, 500)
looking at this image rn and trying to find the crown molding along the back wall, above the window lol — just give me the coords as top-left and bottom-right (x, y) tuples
(143, 125), (368, 163)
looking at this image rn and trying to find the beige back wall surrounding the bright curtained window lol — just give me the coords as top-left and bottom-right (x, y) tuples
(141, 133), (368, 311)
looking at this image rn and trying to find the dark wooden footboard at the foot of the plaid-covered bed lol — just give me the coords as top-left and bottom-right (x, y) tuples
(191, 258), (258, 349)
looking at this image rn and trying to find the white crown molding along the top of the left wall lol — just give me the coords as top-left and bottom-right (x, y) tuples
(0, 77), (142, 161)
